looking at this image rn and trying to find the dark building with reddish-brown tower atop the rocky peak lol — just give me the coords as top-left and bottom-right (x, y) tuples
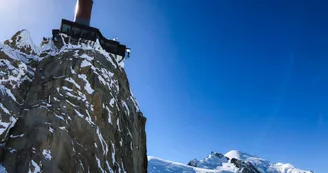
(52, 0), (130, 60)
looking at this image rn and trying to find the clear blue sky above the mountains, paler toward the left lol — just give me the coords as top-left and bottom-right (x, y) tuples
(0, 0), (328, 173)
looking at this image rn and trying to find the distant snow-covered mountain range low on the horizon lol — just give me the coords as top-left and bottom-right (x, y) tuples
(148, 150), (313, 173)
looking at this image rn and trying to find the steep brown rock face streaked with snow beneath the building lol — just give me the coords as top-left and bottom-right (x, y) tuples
(0, 30), (148, 173)
